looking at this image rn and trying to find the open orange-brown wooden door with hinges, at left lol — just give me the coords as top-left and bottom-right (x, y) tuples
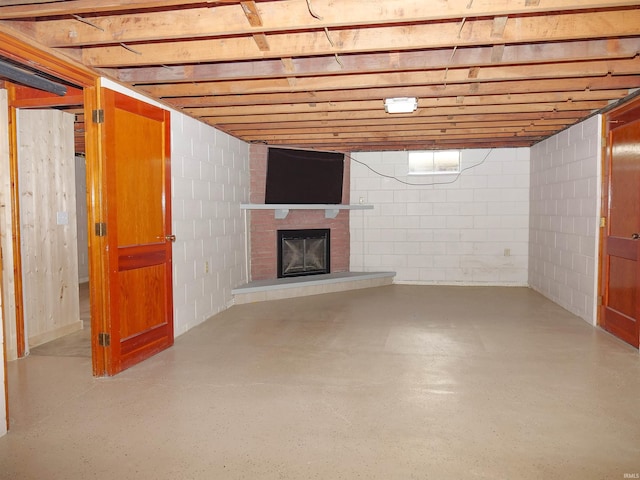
(96, 89), (174, 375)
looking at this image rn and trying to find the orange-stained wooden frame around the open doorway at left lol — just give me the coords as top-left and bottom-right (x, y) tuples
(0, 27), (108, 376)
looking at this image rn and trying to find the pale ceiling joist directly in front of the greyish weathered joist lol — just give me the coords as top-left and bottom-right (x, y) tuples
(71, 9), (640, 67)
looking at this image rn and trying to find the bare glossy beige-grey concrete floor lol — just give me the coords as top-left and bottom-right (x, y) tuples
(0, 285), (640, 480)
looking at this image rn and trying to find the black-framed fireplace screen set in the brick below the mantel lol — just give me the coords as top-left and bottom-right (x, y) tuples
(278, 228), (330, 278)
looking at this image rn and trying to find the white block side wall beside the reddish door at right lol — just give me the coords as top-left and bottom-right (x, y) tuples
(529, 116), (602, 324)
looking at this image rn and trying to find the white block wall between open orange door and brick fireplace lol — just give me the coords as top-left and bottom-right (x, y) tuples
(171, 112), (249, 336)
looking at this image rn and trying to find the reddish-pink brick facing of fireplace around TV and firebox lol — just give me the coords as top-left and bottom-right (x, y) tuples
(248, 144), (350, 280)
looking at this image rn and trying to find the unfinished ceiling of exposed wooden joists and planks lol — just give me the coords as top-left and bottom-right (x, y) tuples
(0, 0), (640, 151)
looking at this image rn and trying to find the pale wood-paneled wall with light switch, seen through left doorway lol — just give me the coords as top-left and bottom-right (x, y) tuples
(17, 110), (82, 347)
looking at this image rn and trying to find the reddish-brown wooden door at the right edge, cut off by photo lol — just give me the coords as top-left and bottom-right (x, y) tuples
(600, 102), (640, 348)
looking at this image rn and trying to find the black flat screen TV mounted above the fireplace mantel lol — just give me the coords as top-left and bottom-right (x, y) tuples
(265, 148), (344, 204)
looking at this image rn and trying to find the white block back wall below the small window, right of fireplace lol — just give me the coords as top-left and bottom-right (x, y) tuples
(350, 148), (529, 285)
